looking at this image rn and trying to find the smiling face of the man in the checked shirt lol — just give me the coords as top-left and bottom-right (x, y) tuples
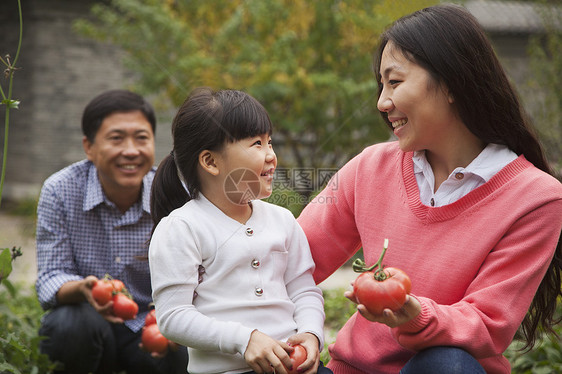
(83, 111), (154, 203)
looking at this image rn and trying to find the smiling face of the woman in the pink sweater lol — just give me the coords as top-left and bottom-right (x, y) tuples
(377, 42), (458, 152)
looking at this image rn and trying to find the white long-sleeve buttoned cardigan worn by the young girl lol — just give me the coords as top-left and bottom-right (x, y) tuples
(149, 194), (324, 374)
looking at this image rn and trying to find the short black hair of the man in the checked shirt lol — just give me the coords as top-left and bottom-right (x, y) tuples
(82, 90), (156, 143)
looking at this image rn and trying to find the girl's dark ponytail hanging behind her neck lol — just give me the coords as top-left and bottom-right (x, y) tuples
(150, 151), (190, 227)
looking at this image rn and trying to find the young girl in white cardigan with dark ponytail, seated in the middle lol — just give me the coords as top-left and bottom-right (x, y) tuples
(149, 88), (329, 374)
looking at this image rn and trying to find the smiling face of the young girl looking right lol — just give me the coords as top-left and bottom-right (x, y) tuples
(218, 134), (277, 204)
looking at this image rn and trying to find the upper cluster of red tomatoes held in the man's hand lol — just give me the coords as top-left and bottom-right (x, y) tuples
(92, 275), (139, 320)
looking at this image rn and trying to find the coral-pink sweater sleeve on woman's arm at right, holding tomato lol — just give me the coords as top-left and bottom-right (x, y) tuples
(392, 200), (562, 359)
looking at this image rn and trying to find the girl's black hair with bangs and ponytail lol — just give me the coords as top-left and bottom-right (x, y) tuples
(150, 87), (273, 226)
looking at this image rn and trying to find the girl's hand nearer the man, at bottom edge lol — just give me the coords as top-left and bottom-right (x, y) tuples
(244, 330), (291, 374)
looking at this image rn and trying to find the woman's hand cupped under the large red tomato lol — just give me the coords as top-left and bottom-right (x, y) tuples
(344, 283), (421, 328)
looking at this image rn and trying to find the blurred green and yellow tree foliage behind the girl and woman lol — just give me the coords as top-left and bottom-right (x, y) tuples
(75, 0), (437, 207)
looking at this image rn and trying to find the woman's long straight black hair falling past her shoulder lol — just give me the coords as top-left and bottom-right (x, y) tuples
(374, 4), (562, 348)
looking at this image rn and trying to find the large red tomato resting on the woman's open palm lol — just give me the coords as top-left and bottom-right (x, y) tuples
(353, 267), (412, 315)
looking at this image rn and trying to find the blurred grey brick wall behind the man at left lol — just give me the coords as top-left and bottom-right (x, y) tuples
(0, 0), (171, 199)
